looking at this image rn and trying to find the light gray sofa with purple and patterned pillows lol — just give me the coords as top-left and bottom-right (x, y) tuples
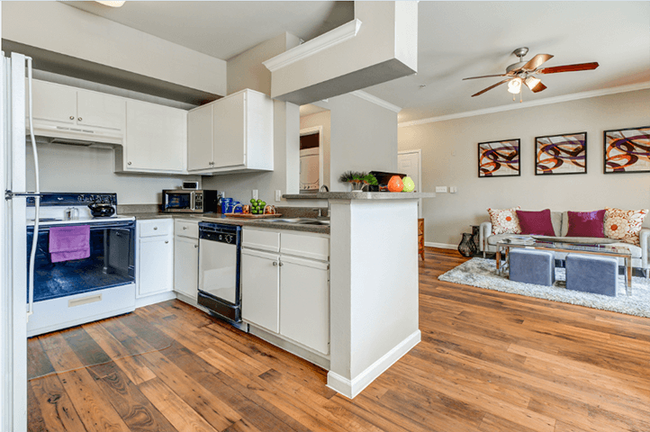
(479, 211), (650, 278)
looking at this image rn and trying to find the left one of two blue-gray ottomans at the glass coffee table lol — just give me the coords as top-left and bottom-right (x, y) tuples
(508, 248), (555, 286)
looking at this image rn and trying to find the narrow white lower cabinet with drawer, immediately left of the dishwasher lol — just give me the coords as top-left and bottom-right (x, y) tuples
(174, 220), (199, 304)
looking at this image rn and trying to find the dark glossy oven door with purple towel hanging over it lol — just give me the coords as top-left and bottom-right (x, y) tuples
(27, 221), (135, 302)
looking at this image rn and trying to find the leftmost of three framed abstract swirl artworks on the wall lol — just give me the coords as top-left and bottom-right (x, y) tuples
(478, 138), (521, 178)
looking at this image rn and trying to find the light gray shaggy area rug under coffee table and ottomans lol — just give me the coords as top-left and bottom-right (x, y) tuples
(438, 258), (650, 318)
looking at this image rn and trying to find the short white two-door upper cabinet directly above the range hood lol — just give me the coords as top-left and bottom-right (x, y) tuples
(32, 80), (126, 131)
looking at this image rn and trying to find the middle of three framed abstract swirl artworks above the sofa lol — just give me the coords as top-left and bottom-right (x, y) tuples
(535, 132), (587, 175)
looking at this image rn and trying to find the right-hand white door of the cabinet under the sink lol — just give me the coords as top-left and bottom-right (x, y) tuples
(280, 256), (330, 354)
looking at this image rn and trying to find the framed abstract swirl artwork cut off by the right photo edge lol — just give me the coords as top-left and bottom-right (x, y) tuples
(603, 126), (650, 174)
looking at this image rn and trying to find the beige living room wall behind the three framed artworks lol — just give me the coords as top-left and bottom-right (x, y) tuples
(398, 90), (650, 245)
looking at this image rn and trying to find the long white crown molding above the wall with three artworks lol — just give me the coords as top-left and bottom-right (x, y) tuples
(397, 82), (650, 127)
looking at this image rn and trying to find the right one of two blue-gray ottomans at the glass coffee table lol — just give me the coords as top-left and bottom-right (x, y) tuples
(566, 254), (618, 297)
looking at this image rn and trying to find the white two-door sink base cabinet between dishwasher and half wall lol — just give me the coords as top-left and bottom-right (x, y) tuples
(241, 227), (330, 355)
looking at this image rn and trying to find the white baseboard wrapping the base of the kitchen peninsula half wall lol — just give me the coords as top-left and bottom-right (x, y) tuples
(327, 330), (422, 399)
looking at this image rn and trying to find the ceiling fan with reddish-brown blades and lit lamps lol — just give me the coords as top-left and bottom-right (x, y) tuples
(463, 47), (598, 102)
